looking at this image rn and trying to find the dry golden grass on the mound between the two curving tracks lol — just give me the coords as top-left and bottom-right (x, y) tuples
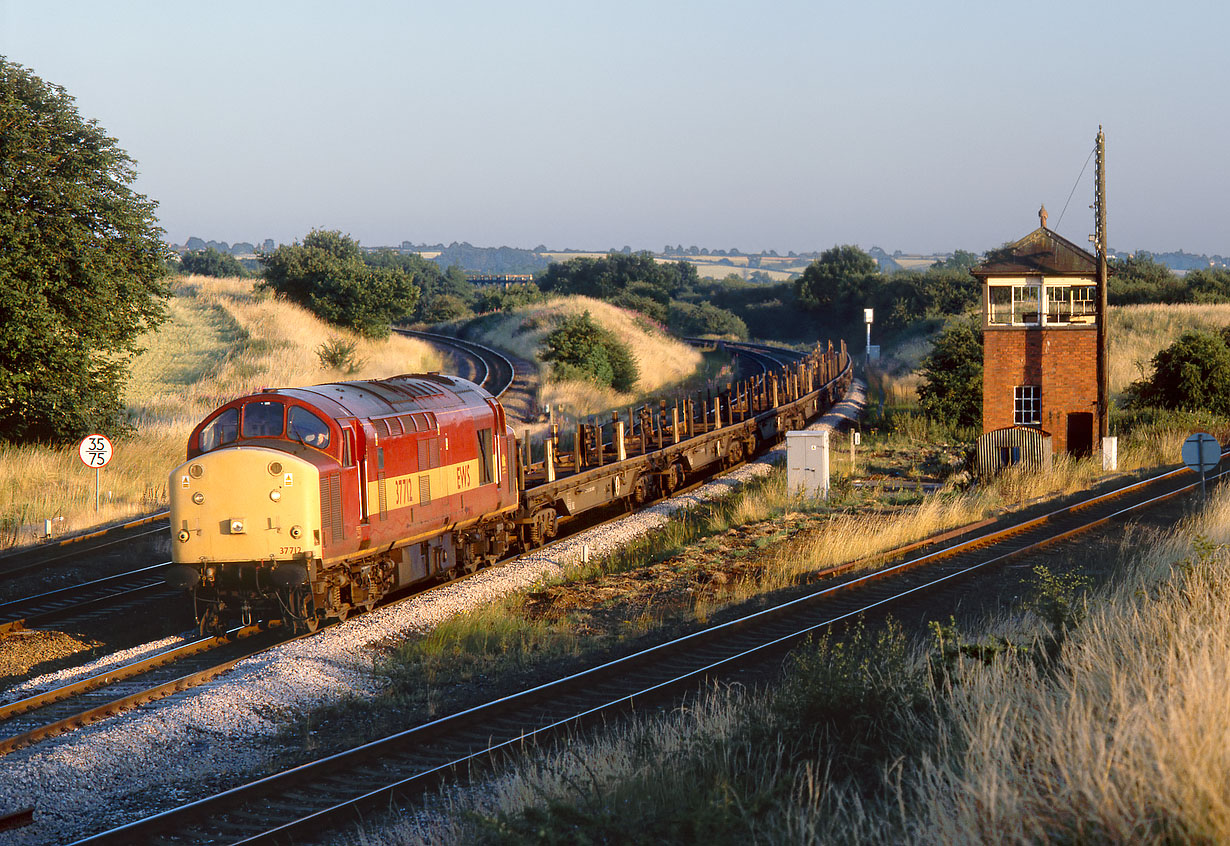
(464, 296), (702, 416)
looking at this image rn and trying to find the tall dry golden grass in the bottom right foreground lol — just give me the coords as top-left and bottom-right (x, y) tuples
(905, 492), (1230, 844)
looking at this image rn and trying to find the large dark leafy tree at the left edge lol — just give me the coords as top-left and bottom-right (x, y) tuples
(0, 57), (170, 443)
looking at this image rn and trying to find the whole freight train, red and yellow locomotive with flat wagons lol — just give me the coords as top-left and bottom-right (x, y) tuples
(166, 344), (851, 632)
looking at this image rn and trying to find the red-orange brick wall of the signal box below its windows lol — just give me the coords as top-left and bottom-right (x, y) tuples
(983, 326), (1097, 453)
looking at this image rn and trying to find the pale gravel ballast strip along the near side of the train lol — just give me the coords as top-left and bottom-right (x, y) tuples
(0, 382), (866, 846)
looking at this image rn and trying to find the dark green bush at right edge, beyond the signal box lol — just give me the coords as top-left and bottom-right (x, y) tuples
(1128, 330), (1230, 414)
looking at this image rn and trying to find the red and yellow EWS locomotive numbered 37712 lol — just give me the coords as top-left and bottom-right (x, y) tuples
(167, 374), (519, 631)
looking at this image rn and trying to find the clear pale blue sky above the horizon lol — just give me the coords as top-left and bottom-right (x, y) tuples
(0, 0), (1230, 255)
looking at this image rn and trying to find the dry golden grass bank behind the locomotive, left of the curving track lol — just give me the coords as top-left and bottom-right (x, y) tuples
(0, 277), (440, 545)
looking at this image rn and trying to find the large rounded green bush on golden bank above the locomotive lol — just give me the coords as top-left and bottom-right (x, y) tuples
(261, 229), (419, 338)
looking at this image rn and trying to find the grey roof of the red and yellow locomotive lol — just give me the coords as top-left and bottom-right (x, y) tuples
(262, 373), (491, 417)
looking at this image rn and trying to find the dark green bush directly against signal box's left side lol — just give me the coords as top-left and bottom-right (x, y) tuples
(919, 321), (983, 427)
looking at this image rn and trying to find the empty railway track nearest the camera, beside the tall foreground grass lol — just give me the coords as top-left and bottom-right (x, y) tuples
(79, 452), (1220, 844)
